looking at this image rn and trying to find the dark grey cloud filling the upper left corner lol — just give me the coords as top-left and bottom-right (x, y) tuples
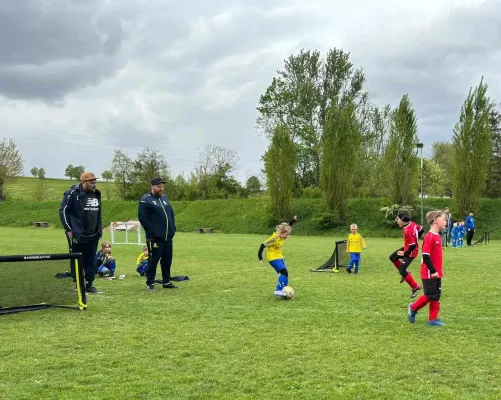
(0, 0), (131, 100)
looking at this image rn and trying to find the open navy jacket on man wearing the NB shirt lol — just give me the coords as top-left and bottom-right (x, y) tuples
(59, 184), (103, 239)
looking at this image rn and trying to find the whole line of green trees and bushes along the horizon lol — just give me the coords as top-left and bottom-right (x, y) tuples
(0, 49), (501, 227)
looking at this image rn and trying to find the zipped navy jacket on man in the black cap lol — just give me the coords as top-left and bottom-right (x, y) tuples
(137, 192), (176, 240)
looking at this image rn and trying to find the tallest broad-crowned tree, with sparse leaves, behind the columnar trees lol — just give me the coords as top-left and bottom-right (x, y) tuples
(257, 49), (367, 187)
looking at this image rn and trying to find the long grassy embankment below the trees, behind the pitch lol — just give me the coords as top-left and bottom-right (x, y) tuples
(0, 197), (501, 240)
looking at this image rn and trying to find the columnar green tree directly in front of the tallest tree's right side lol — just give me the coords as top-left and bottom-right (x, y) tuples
(321, 101), (361, 224)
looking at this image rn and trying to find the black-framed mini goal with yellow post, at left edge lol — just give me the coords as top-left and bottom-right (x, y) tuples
(0, 253), (87, 314)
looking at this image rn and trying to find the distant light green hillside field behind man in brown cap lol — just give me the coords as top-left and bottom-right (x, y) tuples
(5, 177), (116, 201)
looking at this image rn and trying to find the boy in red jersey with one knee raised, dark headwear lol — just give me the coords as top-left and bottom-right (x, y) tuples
(390, 210), (424, 299)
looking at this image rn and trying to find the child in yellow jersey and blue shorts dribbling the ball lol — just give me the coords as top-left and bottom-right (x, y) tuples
(257, 215), (297, 297)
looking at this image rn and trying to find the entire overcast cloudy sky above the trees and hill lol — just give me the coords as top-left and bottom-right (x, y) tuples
(0, 0), (501, 181)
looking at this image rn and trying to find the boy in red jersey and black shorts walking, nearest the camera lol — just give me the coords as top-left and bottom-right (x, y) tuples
(407, 211), (447, 326)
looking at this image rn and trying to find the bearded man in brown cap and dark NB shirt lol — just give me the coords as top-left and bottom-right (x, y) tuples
(59, 172), (103, 293)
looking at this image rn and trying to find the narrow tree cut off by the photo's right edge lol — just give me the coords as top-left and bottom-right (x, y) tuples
(485, 105), (501, 198)
